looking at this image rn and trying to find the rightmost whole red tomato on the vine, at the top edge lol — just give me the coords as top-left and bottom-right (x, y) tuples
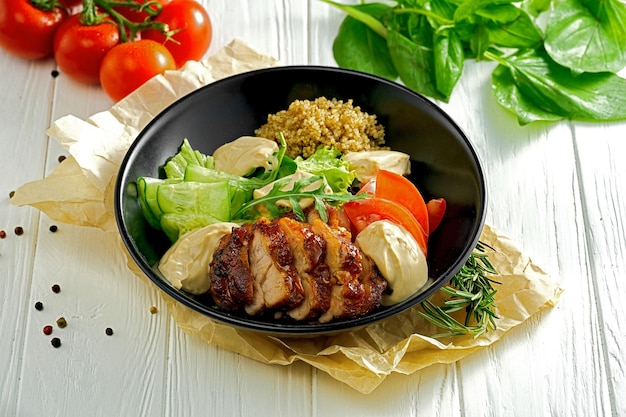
(141, 0), (213, 68)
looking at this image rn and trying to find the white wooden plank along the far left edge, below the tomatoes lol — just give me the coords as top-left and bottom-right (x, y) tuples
(0, 51), (54, 416)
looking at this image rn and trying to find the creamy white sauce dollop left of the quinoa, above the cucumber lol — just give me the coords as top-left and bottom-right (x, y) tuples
(213, 136), (278, 176)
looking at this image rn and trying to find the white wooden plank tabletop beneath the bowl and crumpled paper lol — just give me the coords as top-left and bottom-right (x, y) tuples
(0, 0), (626, 417)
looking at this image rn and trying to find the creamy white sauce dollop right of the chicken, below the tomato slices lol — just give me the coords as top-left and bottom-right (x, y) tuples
(356, 220), (428, 306)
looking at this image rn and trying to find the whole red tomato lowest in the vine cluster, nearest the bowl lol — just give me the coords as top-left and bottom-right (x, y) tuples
(100, 39), (176, 101)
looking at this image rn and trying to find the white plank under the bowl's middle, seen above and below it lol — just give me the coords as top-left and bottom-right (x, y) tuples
(162, 1), (311, 416)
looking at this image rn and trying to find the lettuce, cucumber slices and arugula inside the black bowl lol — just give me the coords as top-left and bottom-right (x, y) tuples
(137, 136), (366, 242)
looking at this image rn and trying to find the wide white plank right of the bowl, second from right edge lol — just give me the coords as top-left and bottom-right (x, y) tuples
(449, 63), (610, 416)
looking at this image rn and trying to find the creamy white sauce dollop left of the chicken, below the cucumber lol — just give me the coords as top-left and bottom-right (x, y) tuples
(159, 222), (239, 294)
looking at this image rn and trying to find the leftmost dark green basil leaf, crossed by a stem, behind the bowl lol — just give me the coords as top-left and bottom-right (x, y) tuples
(326, 3), (398, 80)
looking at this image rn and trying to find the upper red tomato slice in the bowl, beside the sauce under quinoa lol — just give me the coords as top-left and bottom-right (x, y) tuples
(359, 169), (430, 236)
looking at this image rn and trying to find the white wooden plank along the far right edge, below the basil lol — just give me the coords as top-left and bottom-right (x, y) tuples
(574, 122), (626, 415)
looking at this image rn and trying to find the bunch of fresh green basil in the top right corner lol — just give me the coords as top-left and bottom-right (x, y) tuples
(320, 0), (626, 125)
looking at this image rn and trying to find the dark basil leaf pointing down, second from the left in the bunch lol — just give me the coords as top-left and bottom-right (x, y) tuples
(387, 30), (448, 101)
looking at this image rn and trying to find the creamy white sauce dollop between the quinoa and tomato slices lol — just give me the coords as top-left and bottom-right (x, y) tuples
(343, 150), (411, 183)
